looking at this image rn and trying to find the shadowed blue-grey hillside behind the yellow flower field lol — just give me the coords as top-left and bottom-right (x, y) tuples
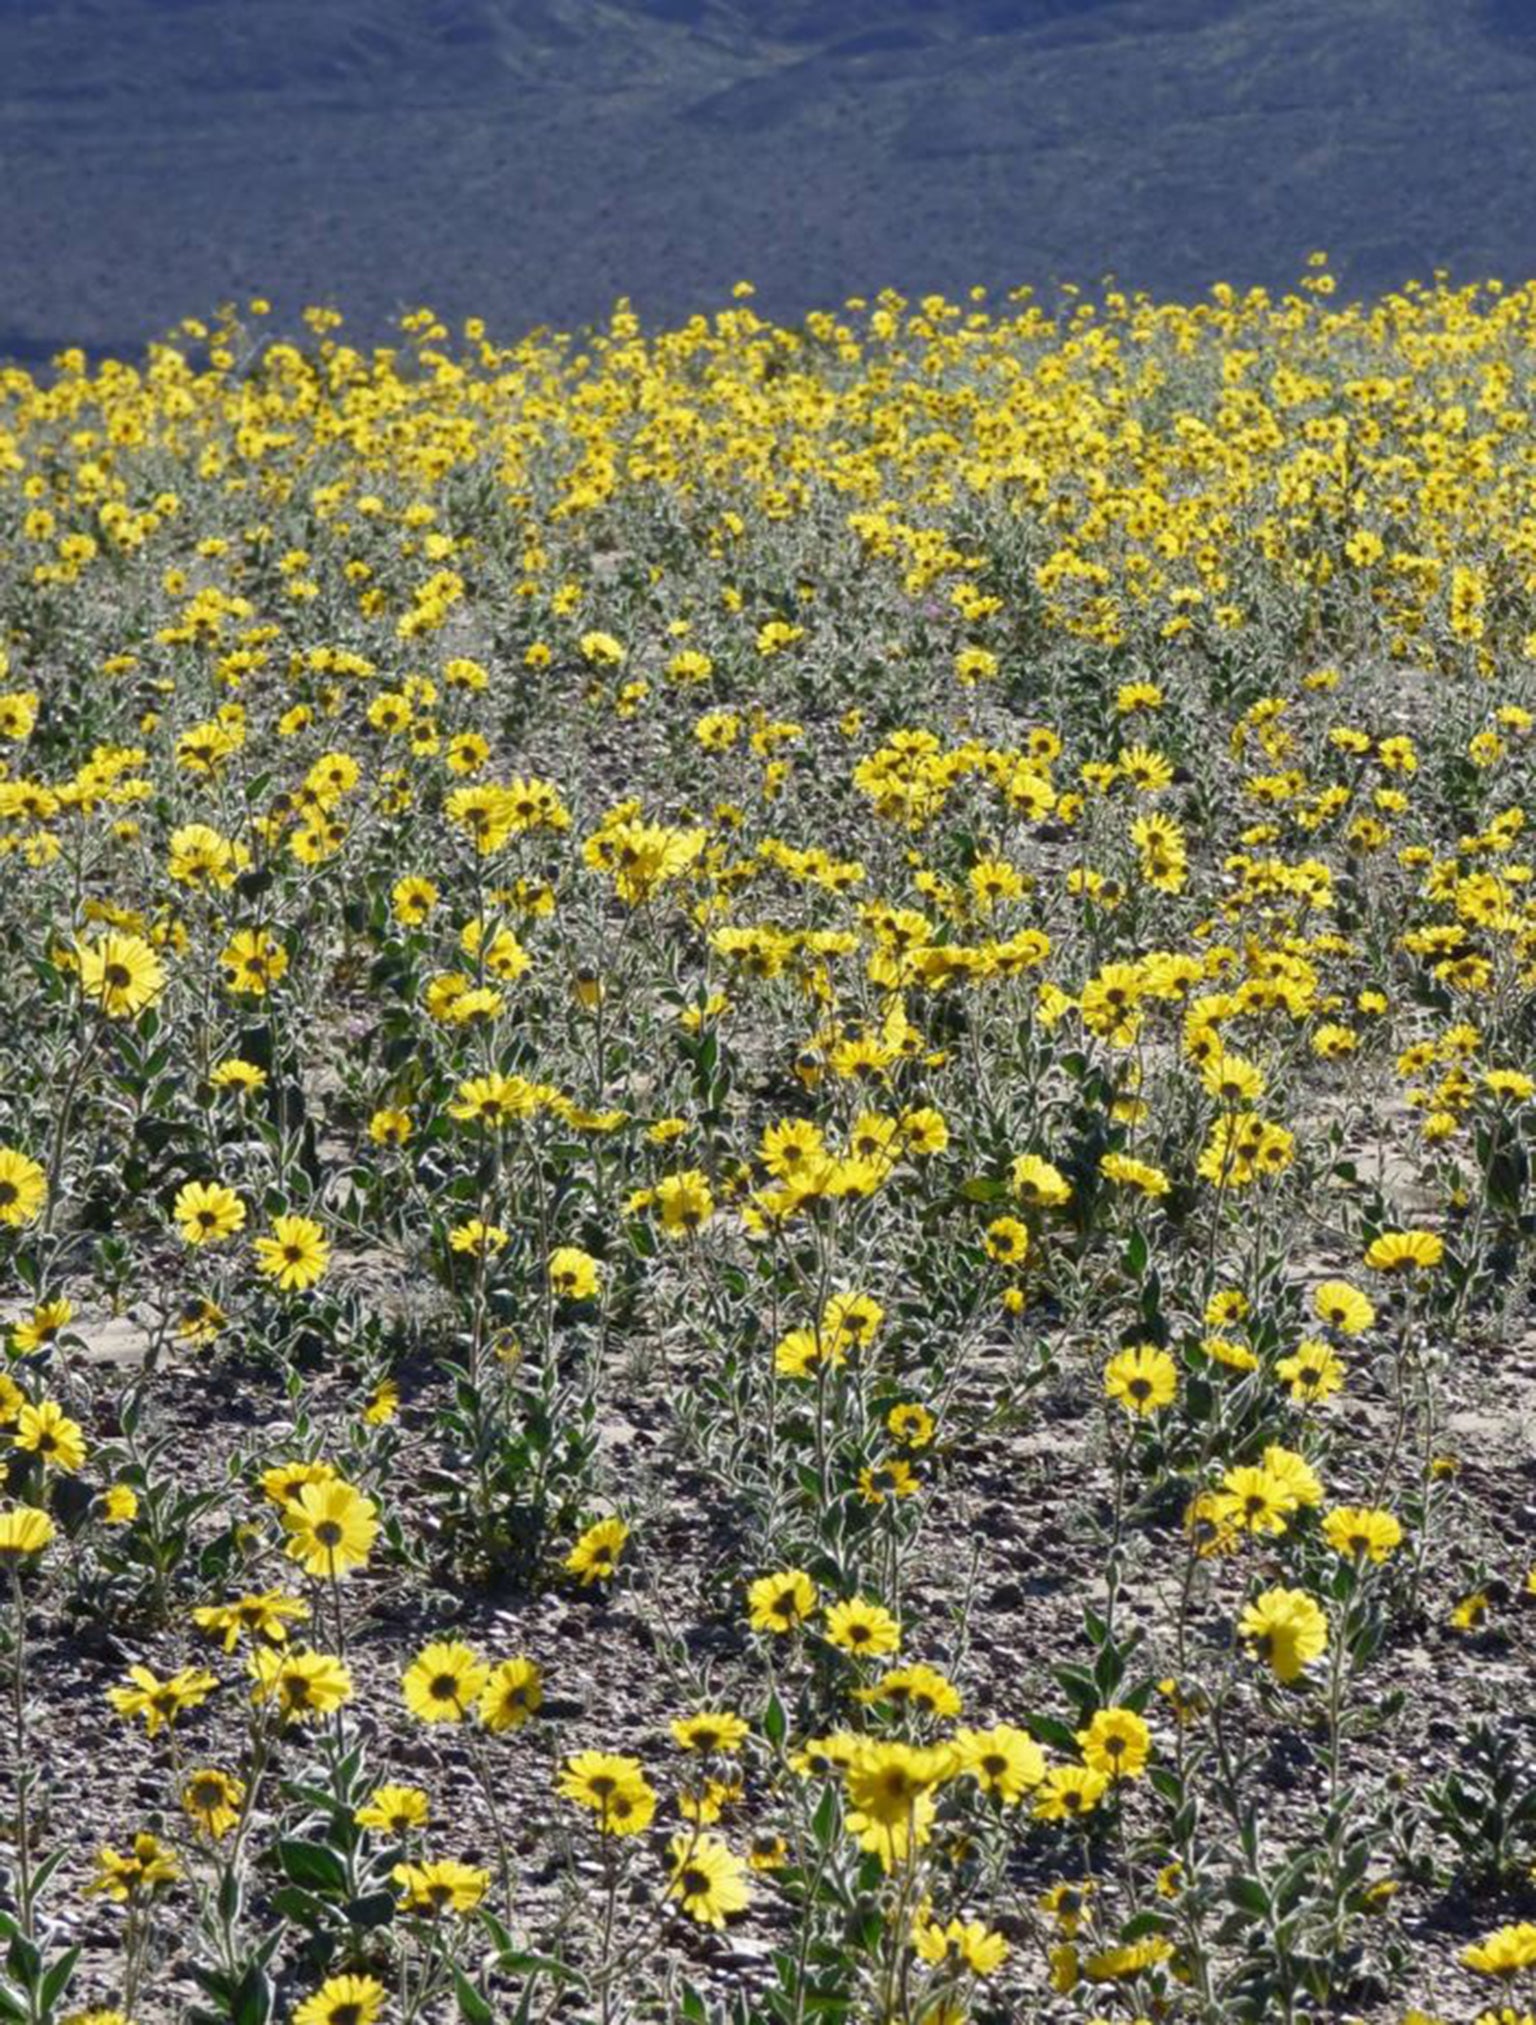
(0, 0), (1536, 358)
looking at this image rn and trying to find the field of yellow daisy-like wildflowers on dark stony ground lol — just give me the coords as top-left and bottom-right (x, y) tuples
(0, 261), (1536, 2025)
